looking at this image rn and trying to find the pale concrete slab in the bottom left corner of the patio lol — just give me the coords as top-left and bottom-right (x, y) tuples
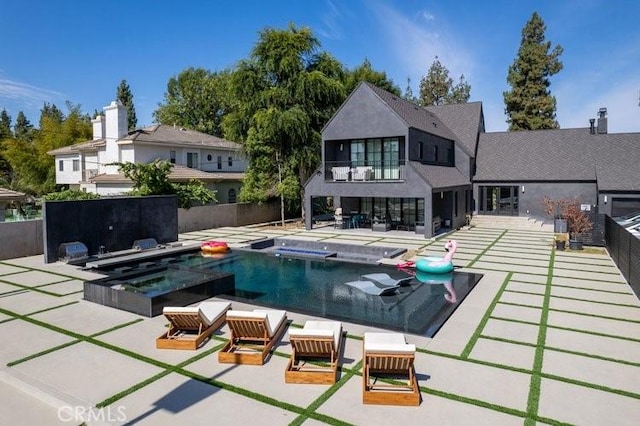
(0, 380), (69, 426)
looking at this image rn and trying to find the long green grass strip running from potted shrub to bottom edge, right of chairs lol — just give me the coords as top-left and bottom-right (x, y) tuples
(525, 243), (555, 426)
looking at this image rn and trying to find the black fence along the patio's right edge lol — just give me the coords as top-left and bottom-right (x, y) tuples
(605, 216), (640, 299)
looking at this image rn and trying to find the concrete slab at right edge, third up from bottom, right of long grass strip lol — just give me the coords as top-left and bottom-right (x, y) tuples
(545, 328), (640, 363)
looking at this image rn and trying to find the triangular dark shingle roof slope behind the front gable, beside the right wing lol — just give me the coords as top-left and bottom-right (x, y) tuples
(425, 102), (484, 157)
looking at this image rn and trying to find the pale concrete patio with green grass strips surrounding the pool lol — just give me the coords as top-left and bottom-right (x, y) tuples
(0, 223), (640, 425)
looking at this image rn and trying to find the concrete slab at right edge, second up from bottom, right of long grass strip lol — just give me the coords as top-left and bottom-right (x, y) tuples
(542, 344), (640, 394)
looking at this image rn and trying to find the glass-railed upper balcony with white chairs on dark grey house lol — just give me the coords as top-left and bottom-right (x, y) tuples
(324, 160), (406, 182)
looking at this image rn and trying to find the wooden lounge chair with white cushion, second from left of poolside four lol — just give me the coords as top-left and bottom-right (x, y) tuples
(218, 309), (287, 365)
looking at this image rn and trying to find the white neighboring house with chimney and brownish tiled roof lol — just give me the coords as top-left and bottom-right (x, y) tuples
(48, 101), (247, 204)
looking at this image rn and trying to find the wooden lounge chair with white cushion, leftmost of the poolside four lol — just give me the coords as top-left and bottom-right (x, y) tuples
(156, 302), (231, 350)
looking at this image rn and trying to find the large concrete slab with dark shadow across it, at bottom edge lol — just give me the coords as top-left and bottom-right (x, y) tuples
(103, 373), (298, 426)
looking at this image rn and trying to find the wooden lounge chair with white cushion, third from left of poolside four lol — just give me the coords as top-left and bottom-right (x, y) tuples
(284, 321), (342, 385)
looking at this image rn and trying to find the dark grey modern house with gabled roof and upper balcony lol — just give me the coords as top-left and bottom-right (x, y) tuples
(305, 82), (640, 237)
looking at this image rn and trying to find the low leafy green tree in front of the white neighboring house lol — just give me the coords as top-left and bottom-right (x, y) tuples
(112, 160), (216, 209)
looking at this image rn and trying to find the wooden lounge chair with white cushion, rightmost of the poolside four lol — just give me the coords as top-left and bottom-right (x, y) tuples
(362, 333), (420, 405)
